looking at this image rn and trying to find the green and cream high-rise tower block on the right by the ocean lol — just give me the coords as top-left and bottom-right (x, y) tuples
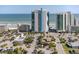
(56, 12), (75, 32)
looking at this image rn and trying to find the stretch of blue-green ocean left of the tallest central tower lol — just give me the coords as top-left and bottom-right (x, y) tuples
(0, 14), (31, 24)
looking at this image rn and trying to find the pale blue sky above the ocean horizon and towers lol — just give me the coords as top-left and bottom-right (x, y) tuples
(0, 5), (79, 14)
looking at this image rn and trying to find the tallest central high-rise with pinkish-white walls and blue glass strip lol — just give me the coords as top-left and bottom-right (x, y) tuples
(32, 8), (49, 32)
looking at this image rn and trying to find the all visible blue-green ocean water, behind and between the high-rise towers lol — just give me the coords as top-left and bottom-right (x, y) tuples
(0, 14), (79, 24)
